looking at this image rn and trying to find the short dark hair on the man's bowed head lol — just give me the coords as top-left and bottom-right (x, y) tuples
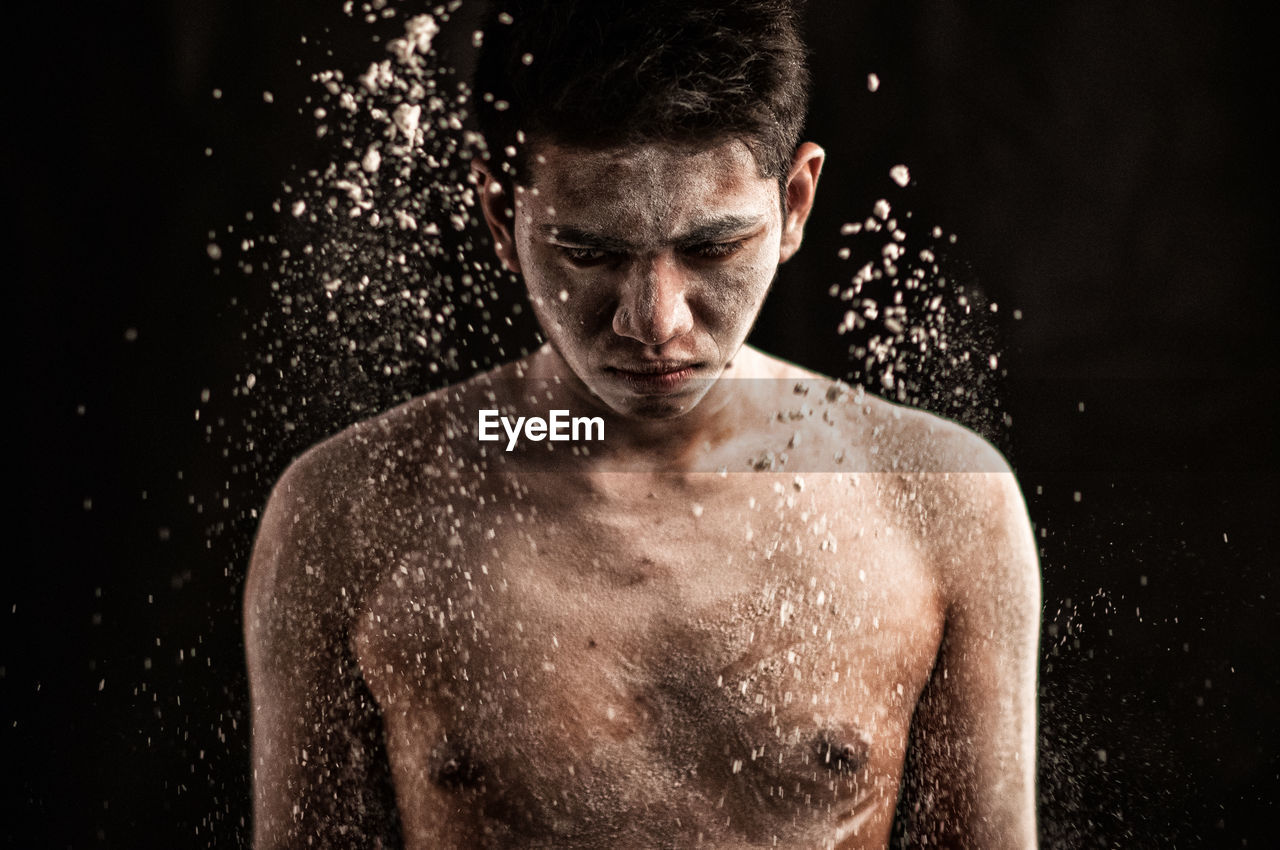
(474, 0), (809, 180)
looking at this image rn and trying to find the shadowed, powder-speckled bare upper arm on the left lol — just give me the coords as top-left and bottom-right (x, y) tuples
(244, 457), (399, 850)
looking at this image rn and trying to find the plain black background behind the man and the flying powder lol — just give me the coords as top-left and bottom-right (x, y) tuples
(0, 0), (1280, 847)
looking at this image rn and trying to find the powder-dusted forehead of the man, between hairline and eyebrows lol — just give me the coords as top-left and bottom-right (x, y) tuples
(526, 140), (781, 238)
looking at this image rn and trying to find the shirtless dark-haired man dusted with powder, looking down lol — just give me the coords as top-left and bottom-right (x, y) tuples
(246, 0), (1039, 850)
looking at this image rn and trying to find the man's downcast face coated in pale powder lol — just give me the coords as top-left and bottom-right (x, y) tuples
(481, 141), (820, 419)
